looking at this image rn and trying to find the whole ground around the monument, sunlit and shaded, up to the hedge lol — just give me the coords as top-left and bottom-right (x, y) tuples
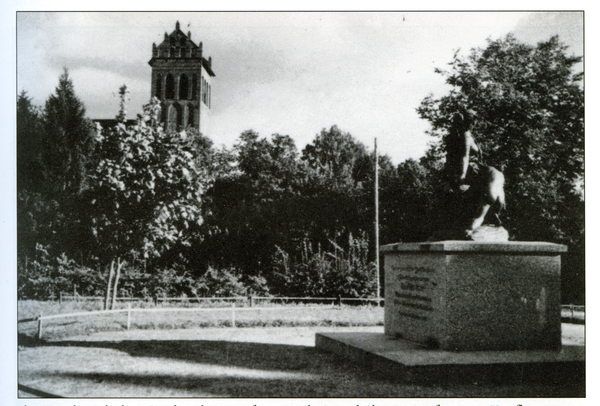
(18, 304), (585, 398)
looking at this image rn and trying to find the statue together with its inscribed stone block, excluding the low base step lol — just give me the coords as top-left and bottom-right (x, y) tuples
(382, 109), (566, 351)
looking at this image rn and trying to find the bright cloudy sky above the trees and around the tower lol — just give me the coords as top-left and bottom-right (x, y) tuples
(16, 11), (583, 164)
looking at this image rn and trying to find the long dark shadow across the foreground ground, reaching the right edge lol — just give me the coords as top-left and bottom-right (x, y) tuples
(19, 335), (585, 398)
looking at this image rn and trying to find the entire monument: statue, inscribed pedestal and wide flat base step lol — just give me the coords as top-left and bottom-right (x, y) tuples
(316, 109), (584, 378)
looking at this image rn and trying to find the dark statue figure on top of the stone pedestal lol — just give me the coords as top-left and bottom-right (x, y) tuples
(436, 109), (508, 241)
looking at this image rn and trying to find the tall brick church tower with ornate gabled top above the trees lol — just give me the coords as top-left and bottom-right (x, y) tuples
(148, 21), (215, 135)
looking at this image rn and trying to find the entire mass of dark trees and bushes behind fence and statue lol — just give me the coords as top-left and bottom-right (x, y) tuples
(17, 35), (585, 303)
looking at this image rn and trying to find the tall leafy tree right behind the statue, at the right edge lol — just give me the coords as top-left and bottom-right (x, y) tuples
(418, 35), (584, 244)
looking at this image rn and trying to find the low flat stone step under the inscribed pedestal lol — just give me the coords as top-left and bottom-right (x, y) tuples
(315, 326), (585, 384)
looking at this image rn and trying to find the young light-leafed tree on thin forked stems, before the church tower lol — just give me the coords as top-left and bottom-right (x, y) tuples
(86, 94), (202, 310)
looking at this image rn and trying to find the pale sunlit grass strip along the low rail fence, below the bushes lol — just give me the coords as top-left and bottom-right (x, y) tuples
(18, 301), (383, 340)
